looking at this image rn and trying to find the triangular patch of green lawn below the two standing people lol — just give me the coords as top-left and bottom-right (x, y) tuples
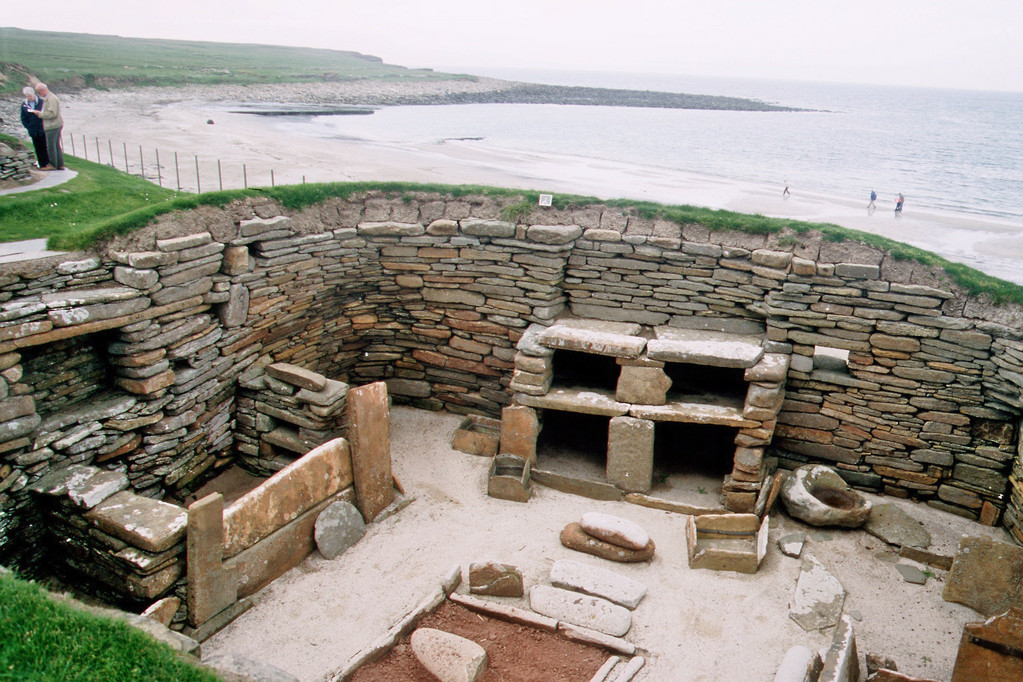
(0, 156), (179, 241)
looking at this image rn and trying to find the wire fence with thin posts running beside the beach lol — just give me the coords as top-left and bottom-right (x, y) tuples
(68, 133), (298, 193)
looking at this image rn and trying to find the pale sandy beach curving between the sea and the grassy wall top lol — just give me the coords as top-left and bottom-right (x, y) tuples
(64, 89), (1023, 283)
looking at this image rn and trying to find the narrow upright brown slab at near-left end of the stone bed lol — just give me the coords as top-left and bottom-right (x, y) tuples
(185, 493), (238, 627)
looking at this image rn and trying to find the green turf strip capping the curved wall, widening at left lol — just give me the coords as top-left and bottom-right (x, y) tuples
(6, 157), (1023, 305)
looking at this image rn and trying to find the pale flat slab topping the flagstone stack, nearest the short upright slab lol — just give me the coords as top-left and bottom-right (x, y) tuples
(85, 491), (188, 552)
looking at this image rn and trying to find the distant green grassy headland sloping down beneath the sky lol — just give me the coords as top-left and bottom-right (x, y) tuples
(0, 28), (458, 92)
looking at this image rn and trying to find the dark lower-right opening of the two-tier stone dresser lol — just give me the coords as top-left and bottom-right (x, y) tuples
(651, 421), (737, 506)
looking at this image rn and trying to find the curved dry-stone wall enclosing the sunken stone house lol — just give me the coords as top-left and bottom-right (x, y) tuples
(0, 191), (1023, 609)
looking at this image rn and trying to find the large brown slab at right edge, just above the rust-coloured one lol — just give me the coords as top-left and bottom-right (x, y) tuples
(941, 536), (1023, 616)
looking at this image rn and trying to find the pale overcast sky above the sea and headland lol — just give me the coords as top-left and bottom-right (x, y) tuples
(0, 0), (1023, 92)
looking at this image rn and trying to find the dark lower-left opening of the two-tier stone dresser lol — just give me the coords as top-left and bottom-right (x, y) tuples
(536, 410), (610, 483)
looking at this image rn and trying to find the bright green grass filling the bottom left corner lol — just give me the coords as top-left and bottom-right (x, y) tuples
(0, 574), (217, 682)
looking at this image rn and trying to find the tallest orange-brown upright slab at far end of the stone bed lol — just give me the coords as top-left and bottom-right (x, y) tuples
(346, 381), (394, 524)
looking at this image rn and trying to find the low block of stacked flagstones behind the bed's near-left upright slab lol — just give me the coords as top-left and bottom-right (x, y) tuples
(31, 464), (186, 602)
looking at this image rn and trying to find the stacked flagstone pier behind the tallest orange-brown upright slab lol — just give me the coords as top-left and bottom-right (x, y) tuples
(236, 362), (348, 474)
